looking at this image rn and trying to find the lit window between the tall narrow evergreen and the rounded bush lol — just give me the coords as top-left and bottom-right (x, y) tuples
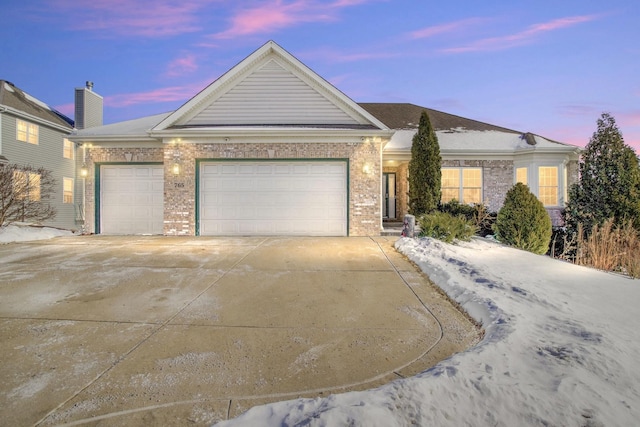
(441, 168), (482, 204)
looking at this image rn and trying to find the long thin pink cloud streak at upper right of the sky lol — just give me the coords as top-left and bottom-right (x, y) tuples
(442, 15), (598, 53)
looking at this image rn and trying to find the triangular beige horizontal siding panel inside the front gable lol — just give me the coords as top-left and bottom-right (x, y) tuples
(187, 59), (358, 125)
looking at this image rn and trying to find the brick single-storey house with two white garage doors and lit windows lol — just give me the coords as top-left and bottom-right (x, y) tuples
(70, 41), (578, 236)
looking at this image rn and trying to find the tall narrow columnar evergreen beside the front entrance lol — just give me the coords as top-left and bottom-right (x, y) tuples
(409, 111), (442, 216)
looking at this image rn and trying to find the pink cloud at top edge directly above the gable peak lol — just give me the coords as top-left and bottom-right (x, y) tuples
(212, 0), (371, 39)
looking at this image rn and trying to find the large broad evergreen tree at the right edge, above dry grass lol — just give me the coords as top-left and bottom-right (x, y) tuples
(565, 113), (640, 233)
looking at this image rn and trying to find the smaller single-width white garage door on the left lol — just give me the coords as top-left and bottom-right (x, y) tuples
(100, 165), (164, 234)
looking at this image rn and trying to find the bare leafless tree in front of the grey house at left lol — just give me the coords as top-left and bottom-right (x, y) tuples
(0, 164), (57, 227)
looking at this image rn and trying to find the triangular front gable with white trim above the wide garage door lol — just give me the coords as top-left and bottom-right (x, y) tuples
(152, 41), (388, 132)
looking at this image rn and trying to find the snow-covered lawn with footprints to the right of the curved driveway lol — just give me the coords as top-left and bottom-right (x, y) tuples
(220, 238), (640, 427)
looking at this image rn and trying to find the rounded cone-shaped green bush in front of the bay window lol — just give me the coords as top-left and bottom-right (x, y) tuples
(493, 182), (551, 254)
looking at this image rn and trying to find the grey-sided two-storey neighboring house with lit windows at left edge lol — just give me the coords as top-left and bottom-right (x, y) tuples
(0, 80), (81, 229)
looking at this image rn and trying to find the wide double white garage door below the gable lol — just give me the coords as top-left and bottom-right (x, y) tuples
(199, 161), (347, 236)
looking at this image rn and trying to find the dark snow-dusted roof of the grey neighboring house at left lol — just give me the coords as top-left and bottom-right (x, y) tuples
(0, 80), (73, 130)
